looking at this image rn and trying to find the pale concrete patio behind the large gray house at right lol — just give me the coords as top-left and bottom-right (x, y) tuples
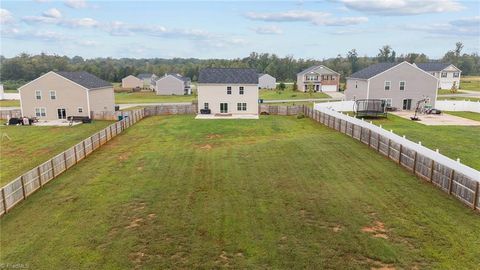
(391, 111), (480, 126)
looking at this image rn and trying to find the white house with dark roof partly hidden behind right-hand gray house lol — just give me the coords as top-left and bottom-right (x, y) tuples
(414, 62), (462, 89)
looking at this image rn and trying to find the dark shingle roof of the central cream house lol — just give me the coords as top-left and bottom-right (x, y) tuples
(198, 68), (258, 84)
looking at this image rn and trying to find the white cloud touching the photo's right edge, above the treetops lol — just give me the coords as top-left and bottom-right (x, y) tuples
(406, 16), (480, 38)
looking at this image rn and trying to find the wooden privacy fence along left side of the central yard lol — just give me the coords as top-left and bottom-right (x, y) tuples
(0, 109), (145, 216)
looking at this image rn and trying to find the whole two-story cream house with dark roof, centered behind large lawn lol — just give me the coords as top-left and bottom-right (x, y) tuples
(197, 68), (258, 115)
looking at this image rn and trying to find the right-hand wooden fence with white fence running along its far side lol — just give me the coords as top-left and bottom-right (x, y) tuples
(303, 107), (480, 211)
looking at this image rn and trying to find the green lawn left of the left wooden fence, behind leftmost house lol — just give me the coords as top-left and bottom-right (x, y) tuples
(0, 121), (113, 185)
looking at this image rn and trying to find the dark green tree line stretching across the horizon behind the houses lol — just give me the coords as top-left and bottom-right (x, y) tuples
(0, 42), (480, 89)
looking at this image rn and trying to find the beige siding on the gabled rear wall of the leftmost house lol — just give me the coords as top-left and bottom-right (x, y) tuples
(19, 72), (89, 120)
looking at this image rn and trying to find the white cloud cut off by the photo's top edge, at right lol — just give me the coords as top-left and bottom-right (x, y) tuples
(336, 0), (464, 16)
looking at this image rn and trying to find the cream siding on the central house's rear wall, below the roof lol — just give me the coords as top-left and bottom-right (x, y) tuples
(197, 83), (258, 115)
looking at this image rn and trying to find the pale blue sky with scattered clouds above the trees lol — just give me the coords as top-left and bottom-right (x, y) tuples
(0, 0), (480, 59)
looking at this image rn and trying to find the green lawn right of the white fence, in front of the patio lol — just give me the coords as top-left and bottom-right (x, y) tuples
(373, 112), (480, 170)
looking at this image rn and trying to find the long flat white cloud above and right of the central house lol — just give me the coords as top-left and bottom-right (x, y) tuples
(245, 10), (368, 26)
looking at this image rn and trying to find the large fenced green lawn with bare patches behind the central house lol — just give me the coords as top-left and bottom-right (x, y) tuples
(0, 116), (480, 269)
